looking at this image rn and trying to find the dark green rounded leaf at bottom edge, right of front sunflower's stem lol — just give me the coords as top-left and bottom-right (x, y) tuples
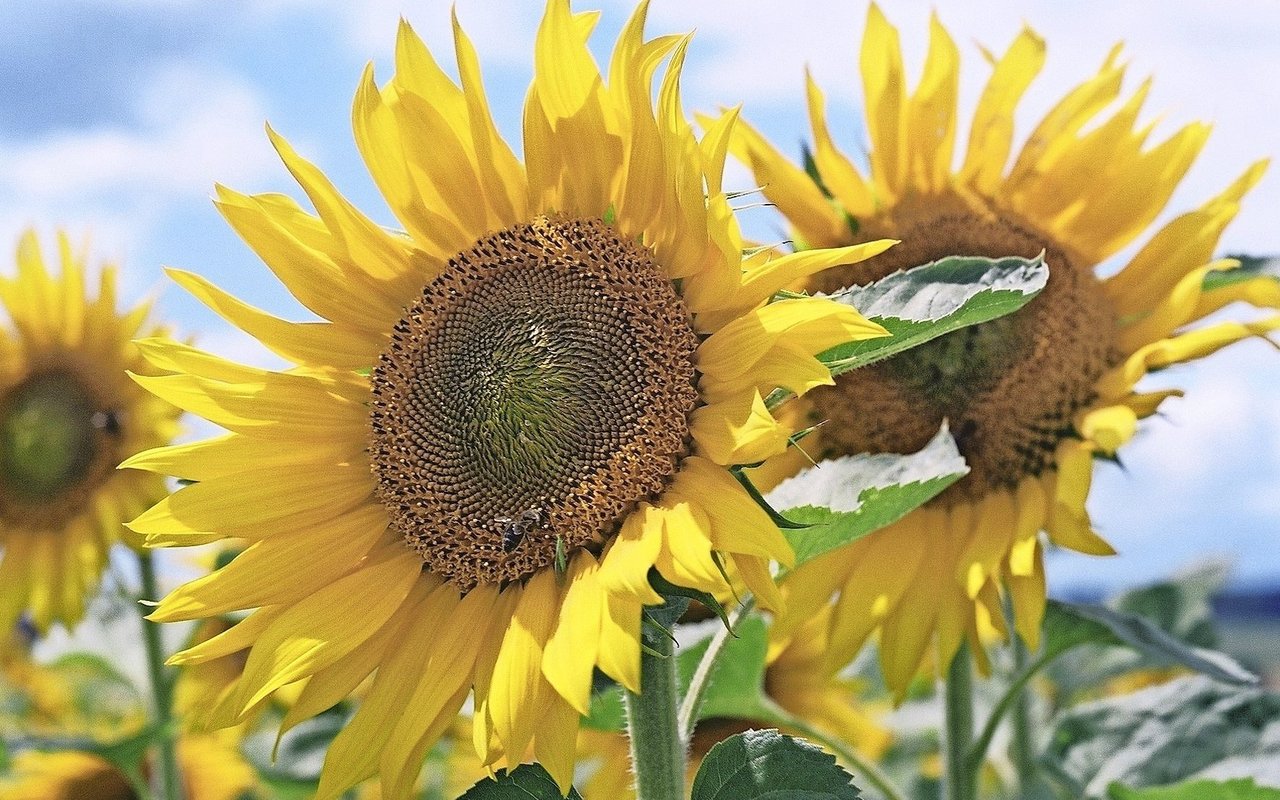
(692, 730), (861, 800)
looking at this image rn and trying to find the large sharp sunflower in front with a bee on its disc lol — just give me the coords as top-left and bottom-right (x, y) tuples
(128, 0), (888, 797)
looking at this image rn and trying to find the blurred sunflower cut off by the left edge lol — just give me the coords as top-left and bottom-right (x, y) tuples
(0, 232), (178, 634)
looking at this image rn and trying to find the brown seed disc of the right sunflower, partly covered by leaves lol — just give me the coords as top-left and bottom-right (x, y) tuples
(809, 212), (1116, 506)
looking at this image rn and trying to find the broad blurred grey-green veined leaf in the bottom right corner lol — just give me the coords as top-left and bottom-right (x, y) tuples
(1041, 676), (1280, 799)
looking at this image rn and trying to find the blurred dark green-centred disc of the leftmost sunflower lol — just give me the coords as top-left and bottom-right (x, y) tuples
(0, 372), (97, 503)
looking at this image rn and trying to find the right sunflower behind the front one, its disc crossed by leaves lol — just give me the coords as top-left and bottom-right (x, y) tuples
(735, 5), (1280, 692)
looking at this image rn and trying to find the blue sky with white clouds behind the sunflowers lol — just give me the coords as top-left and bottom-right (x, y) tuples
(0, 0), (1280, 590)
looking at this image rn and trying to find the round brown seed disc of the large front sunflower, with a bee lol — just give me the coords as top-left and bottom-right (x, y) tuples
(370, 218), (698, 590)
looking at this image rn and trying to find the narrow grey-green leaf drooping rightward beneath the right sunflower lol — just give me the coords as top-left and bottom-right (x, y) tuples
(1044, 600), (1258, 686)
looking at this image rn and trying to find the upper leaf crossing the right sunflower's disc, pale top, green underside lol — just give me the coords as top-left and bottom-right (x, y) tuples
(819, 256), (1050, 375)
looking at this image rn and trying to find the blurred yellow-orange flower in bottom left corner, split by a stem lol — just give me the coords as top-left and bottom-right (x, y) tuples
(0, 736), (262, 800)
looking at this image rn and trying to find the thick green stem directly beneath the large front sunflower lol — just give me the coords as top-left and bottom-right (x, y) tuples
(626, 624), (685, 800)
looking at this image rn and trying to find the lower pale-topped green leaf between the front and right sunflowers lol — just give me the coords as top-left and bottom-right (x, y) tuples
(767, 425), (969, 567)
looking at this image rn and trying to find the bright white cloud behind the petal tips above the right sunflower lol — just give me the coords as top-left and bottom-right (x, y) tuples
(650, 0), (1280, 252)
